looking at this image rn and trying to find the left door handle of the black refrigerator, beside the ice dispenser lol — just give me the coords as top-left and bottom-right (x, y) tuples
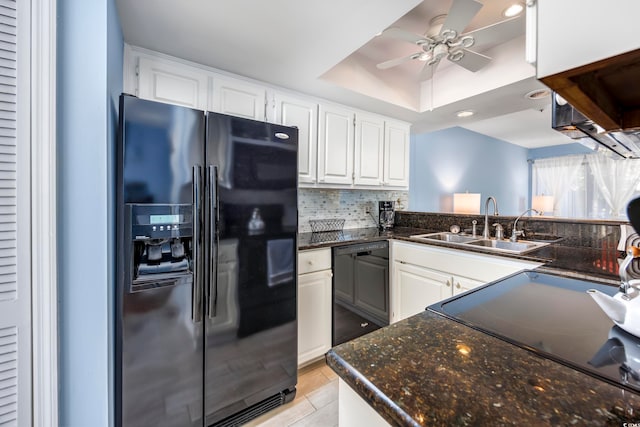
(191, 165), (204, 323)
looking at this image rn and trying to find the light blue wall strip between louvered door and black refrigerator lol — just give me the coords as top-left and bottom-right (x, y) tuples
(57, 0), (124, 427)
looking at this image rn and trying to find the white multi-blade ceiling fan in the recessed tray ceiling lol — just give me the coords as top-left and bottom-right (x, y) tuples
(376, 0), (520, 80)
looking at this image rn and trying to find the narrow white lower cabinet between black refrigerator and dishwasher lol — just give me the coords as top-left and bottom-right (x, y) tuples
(298, 248), (332, 366)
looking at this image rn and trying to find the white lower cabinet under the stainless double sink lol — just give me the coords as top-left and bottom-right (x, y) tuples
(391, 240), (542, 322)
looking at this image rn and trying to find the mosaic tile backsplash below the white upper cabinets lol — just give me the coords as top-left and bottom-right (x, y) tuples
(298, 188), (409, 233)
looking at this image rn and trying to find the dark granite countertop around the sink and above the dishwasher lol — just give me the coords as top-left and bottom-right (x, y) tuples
(298, 227), (624, 284)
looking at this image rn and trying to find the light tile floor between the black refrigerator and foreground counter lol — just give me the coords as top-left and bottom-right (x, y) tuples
(245, 360), (338, 427)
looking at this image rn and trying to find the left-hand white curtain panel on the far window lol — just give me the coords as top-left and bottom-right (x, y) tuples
(533, 155), (584, 215)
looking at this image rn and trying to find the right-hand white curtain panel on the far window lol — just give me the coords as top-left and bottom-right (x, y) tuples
(586, 153), (640, 218)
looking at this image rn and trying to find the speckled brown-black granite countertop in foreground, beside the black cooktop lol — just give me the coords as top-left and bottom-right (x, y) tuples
(326, 311), (640, 426)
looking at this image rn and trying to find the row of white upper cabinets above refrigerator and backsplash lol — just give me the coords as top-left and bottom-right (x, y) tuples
(128, 45), (410, 189)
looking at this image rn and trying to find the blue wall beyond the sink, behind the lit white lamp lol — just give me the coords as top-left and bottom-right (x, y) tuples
(409, 127), (529, 215)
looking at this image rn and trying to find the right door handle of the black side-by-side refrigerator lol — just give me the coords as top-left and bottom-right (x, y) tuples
(207, 165), (219, 319)
